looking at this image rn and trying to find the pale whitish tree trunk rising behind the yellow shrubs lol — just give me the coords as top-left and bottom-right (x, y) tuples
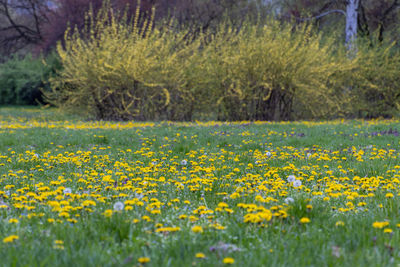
(346, 0), (360, 56)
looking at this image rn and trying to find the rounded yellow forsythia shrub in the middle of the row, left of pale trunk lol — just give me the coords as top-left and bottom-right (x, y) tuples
(198, 21), (352, 120)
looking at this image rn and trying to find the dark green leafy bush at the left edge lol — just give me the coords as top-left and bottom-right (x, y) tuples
(0, 55), (59, 105)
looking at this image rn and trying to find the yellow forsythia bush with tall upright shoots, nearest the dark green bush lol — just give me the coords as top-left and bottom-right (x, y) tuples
(46, 2), (199, 120)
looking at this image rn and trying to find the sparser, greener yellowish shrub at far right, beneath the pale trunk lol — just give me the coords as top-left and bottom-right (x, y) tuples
(350, 40), (400, 118)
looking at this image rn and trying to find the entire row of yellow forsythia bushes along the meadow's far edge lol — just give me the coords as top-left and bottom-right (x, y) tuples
(45, 1), (400, 120)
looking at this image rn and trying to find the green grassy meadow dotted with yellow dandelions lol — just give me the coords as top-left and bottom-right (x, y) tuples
(0, 108), (400, 266)
